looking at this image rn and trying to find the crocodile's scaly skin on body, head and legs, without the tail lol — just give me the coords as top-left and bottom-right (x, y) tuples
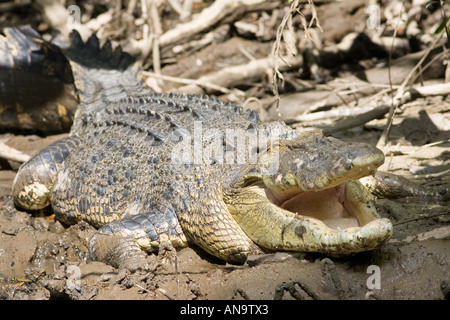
(14, 94), (392, 269)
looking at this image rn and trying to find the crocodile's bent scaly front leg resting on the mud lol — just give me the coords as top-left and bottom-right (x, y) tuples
(89, 198), (261, 271)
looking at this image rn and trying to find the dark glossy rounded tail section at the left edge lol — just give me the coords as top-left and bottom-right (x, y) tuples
(0, 26), (78, 132)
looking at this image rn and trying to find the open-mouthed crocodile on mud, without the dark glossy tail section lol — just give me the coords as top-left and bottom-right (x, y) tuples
(11, 26), (393, 270)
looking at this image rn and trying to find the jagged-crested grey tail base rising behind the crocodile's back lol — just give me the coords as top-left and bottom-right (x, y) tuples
(59, 30), (144, 133)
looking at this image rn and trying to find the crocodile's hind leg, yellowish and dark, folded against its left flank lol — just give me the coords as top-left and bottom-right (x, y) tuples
(12, 136), (81, 210)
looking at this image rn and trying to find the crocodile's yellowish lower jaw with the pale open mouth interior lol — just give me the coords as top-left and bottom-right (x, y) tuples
(228, 175), (393, 255)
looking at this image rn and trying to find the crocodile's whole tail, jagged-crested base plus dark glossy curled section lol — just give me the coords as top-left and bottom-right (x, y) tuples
(0, 26), (143, 133)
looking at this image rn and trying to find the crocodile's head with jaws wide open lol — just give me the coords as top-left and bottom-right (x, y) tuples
(224, 132), (393, 255)
